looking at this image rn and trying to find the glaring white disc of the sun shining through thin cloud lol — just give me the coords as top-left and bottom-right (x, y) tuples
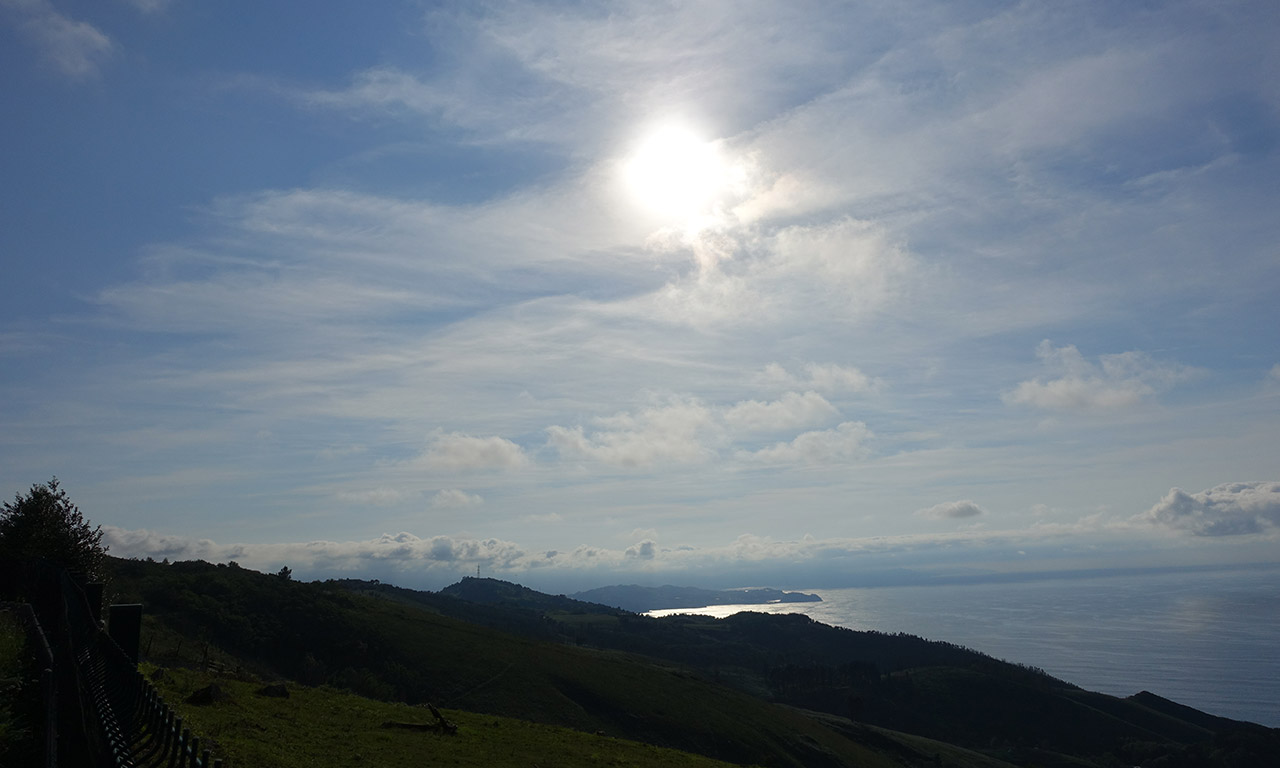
(623, 124), (731, 220)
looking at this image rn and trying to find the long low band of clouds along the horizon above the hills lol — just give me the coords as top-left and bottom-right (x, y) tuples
(102, 517), (1172, 589)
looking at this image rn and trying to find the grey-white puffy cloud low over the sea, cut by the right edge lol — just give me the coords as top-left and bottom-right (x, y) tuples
(1134, 483), (1280, 536)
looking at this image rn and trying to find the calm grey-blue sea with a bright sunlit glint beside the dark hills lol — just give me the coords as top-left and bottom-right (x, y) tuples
(650, 566), (1280, 727)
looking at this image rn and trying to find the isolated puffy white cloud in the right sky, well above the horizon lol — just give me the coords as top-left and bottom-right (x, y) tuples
(1002, 339), (1197, 411)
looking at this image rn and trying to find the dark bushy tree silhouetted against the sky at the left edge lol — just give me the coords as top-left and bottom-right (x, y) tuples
(0, 477), (106, 581)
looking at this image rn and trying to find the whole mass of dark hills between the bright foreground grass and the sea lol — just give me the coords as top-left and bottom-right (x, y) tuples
(108, 559), (1280, 768)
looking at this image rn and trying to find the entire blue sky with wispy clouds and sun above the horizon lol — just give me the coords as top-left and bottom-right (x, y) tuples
(0, 0), (1280, 590)
